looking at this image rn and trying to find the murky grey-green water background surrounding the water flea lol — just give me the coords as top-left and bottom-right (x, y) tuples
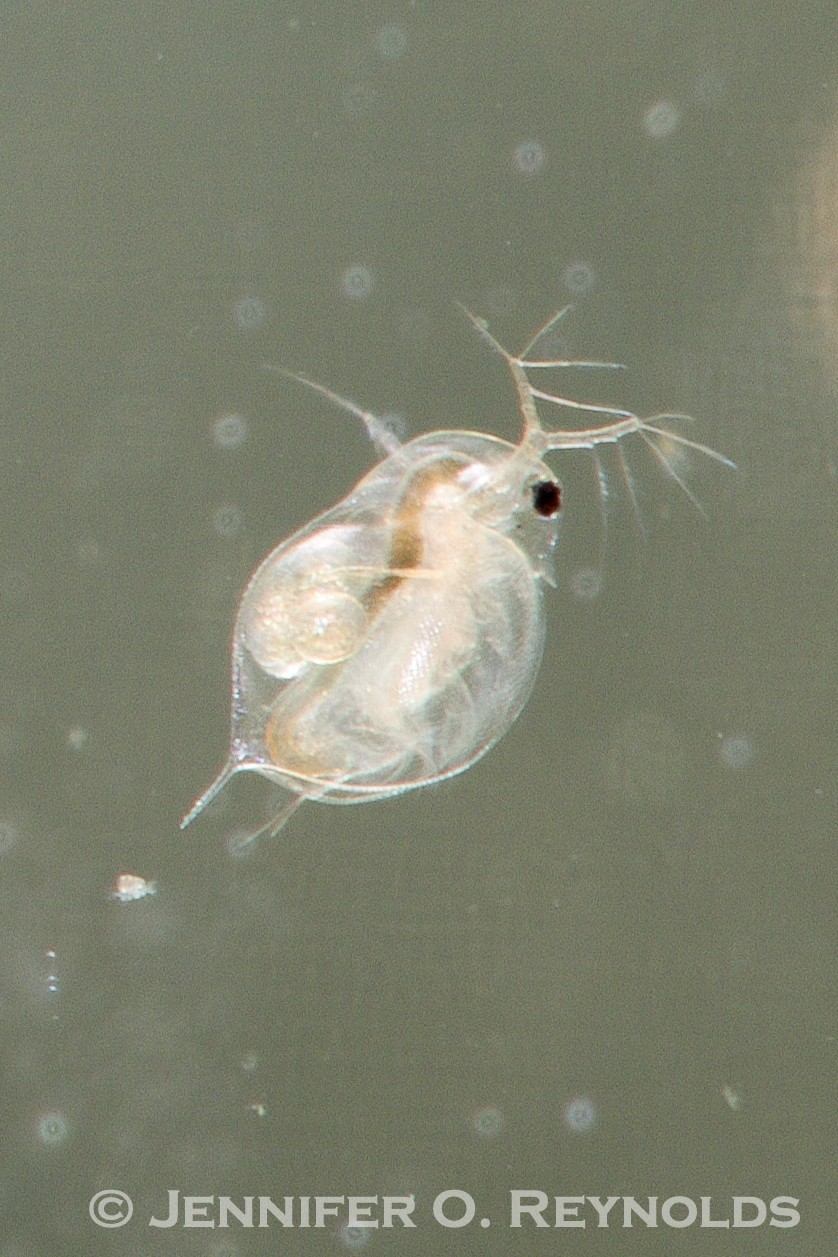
(0, 0), (838, 1257)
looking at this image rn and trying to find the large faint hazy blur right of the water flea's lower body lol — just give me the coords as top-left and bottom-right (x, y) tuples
(606, 711), (686, 807)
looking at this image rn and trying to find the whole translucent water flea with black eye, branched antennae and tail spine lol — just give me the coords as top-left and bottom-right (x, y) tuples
(181, 310), (729, 836)
